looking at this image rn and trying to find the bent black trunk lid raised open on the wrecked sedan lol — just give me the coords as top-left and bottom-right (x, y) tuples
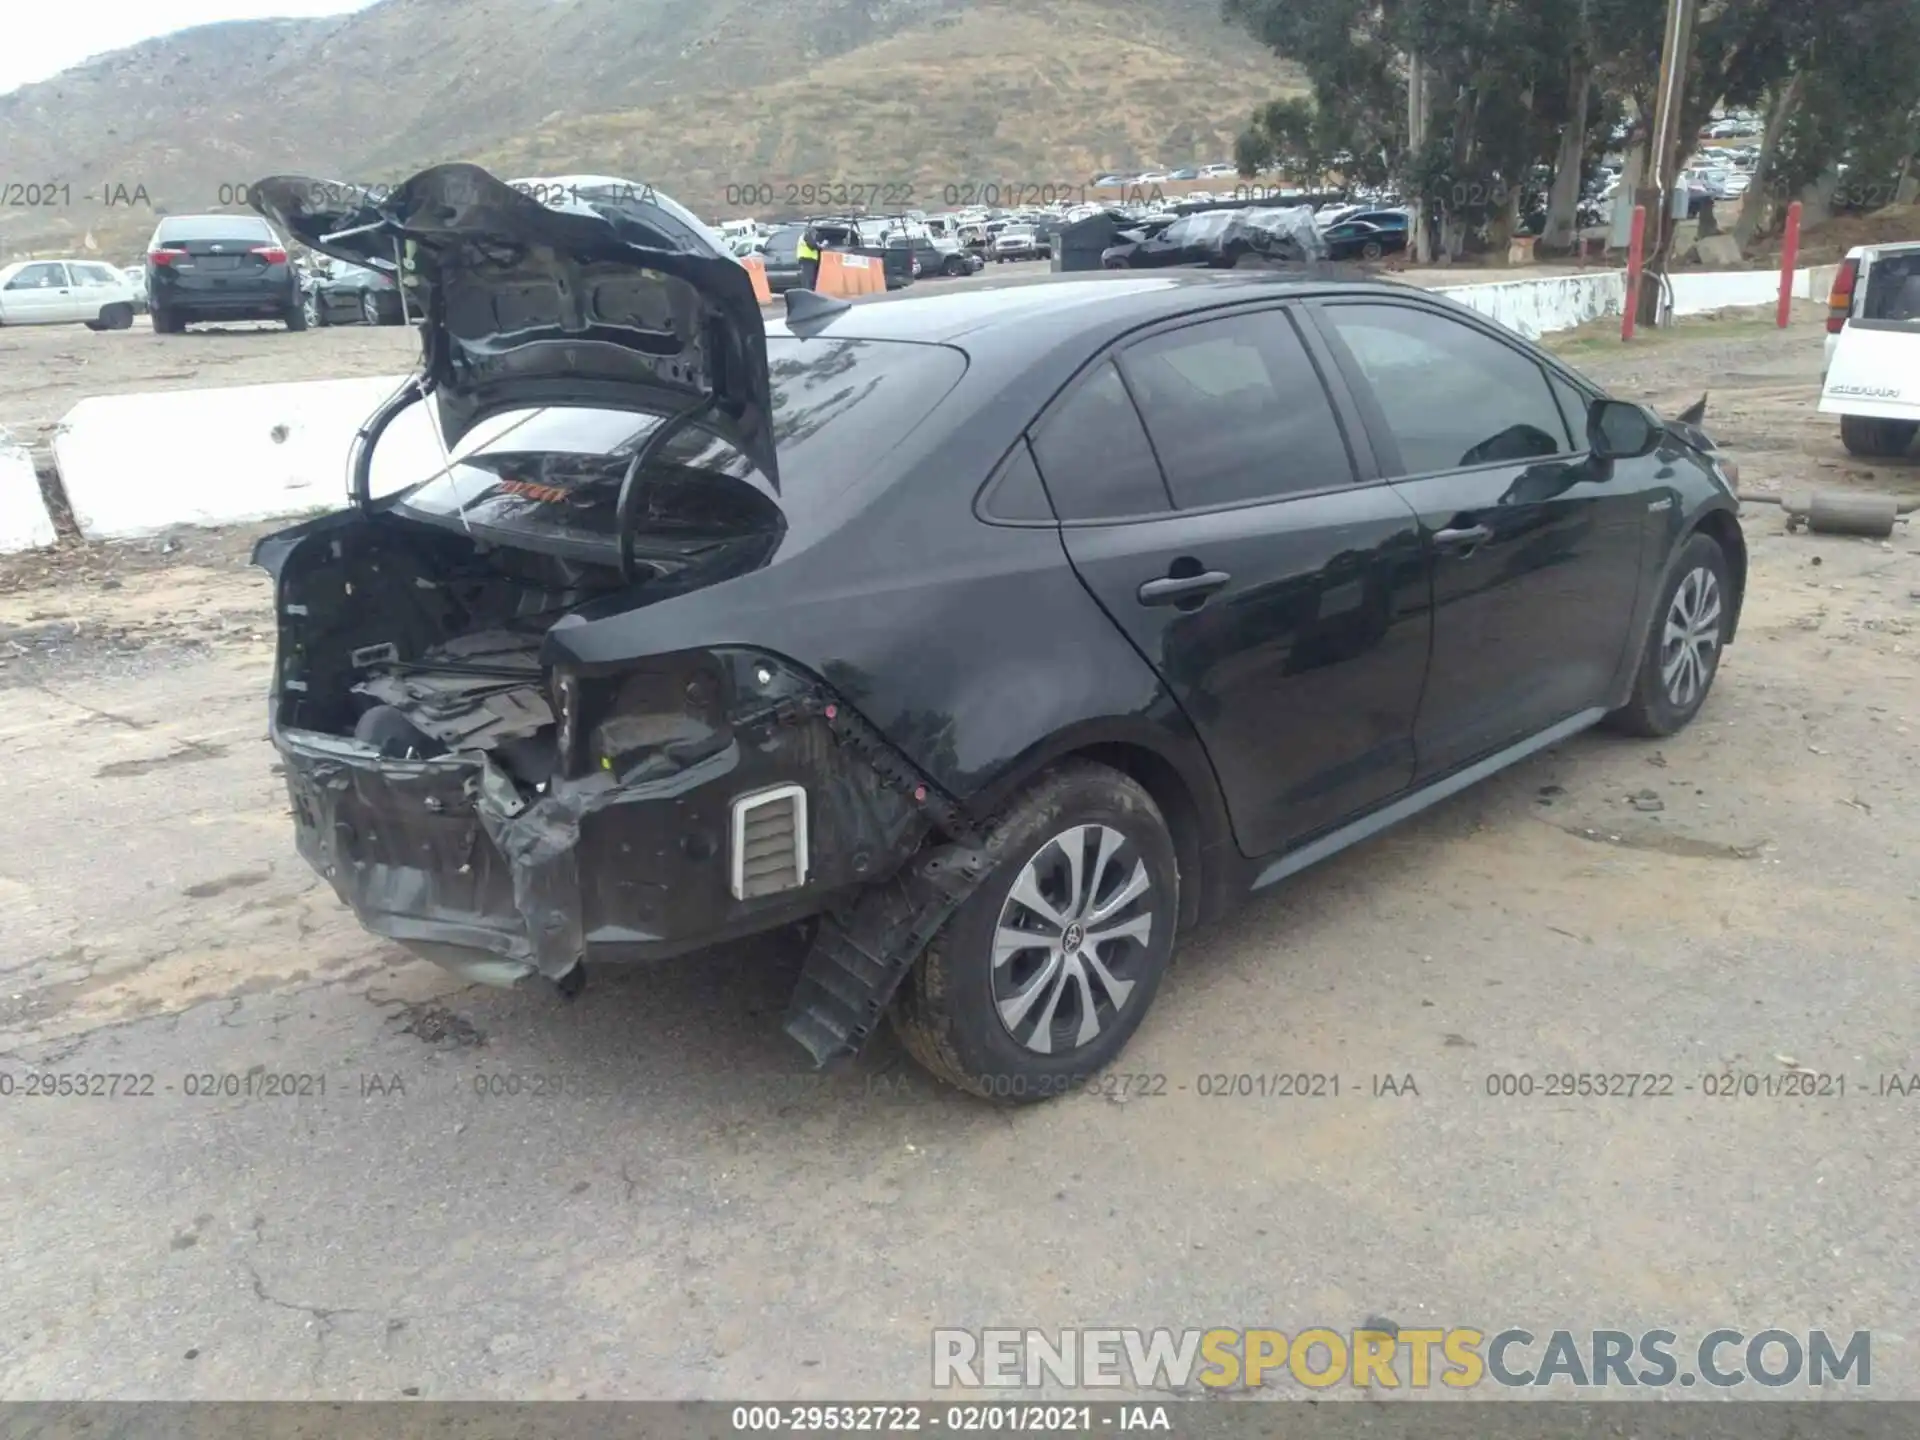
(250, 165), (780, 492)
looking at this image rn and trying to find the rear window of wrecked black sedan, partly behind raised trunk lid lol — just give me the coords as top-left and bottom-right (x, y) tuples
(396, 336), (966, 557)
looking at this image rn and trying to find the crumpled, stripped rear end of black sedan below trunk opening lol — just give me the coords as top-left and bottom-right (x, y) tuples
(273, 653), (968, 1013)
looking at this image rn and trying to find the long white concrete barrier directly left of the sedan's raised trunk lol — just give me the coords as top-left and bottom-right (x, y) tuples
(54, 374), (444, 540)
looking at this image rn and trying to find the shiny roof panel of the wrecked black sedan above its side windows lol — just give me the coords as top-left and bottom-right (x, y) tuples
(768, 271), (1432, 344)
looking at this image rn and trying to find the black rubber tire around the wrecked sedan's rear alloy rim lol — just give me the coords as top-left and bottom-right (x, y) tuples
(891, 760), (1179, 1104)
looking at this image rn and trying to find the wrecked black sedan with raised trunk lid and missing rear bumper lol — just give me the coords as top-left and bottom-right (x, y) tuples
(255, 165), (1747, 1100)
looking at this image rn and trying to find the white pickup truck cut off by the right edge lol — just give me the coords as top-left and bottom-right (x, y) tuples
(1820, 240), (1920, 457)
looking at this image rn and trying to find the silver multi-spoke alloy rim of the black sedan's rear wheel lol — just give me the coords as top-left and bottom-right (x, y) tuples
(993, 826), (1156, 1056)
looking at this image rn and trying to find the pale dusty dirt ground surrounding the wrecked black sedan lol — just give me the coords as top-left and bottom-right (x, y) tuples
(0, 305), (1920, 1400)
